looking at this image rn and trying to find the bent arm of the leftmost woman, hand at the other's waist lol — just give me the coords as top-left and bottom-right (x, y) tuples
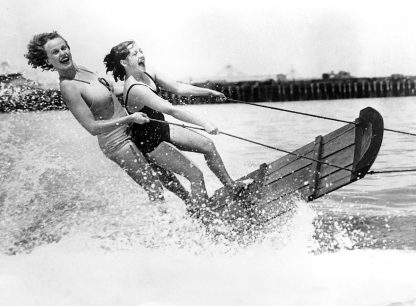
(61, 84), (149, 136)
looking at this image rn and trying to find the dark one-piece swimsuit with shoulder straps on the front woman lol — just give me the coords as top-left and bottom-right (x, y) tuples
(124, 72), (170, 154)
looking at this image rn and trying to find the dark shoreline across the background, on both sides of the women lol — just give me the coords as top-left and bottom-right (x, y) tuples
(0, 73), (416, 113)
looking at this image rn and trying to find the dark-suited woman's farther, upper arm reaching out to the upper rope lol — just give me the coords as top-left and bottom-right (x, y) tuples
(151, 69), (227, 101)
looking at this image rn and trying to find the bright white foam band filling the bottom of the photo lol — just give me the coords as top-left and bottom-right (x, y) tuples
(0, 203), (416, 306)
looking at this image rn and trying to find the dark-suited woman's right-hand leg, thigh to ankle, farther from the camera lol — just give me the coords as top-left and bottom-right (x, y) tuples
(170, 126), (235, 187)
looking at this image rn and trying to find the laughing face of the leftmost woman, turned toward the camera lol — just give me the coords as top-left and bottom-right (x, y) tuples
(43, 37), (73, 70)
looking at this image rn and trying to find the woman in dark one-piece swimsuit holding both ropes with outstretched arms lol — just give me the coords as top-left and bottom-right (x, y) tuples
(104, 41), (247, 210)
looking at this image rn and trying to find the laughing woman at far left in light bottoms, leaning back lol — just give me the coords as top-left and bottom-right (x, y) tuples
(25, 31), (189, 201)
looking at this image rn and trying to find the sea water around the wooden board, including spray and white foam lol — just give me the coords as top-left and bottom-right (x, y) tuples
(0, 97), (416, 306)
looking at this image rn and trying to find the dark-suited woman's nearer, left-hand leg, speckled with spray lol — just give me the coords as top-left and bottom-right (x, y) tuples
(147, 142), (208, 204)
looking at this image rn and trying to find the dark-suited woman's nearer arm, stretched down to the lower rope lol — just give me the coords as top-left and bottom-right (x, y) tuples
(128, 85), (218, 134)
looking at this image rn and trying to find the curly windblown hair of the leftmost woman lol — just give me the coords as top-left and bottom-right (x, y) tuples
(25, 31), (70, 70)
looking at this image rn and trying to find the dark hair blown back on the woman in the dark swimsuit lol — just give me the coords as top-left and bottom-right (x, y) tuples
(104, 40), (134, 82)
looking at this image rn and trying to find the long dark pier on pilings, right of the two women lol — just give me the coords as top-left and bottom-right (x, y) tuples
(163, 75), (416, 104)
